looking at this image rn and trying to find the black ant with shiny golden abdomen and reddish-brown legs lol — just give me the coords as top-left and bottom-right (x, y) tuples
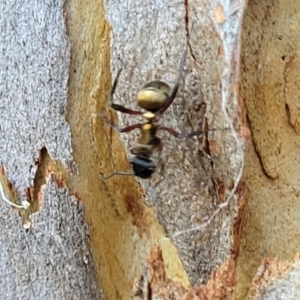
(102, 24), (226, 181)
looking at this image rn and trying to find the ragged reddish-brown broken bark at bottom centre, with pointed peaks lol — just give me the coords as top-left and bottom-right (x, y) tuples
(132, 245), (235, 300)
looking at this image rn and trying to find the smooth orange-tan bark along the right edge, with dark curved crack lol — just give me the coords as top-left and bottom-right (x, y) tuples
(237, 1), (300, 299)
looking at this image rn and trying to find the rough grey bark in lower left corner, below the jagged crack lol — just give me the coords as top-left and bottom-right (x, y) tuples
(0, 178), (101, 300)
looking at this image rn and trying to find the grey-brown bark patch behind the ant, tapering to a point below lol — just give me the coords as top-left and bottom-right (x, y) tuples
(104, 0), (245, 284)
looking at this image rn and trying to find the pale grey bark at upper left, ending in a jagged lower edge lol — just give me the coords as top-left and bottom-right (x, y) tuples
(0, 0), (74, 200)
